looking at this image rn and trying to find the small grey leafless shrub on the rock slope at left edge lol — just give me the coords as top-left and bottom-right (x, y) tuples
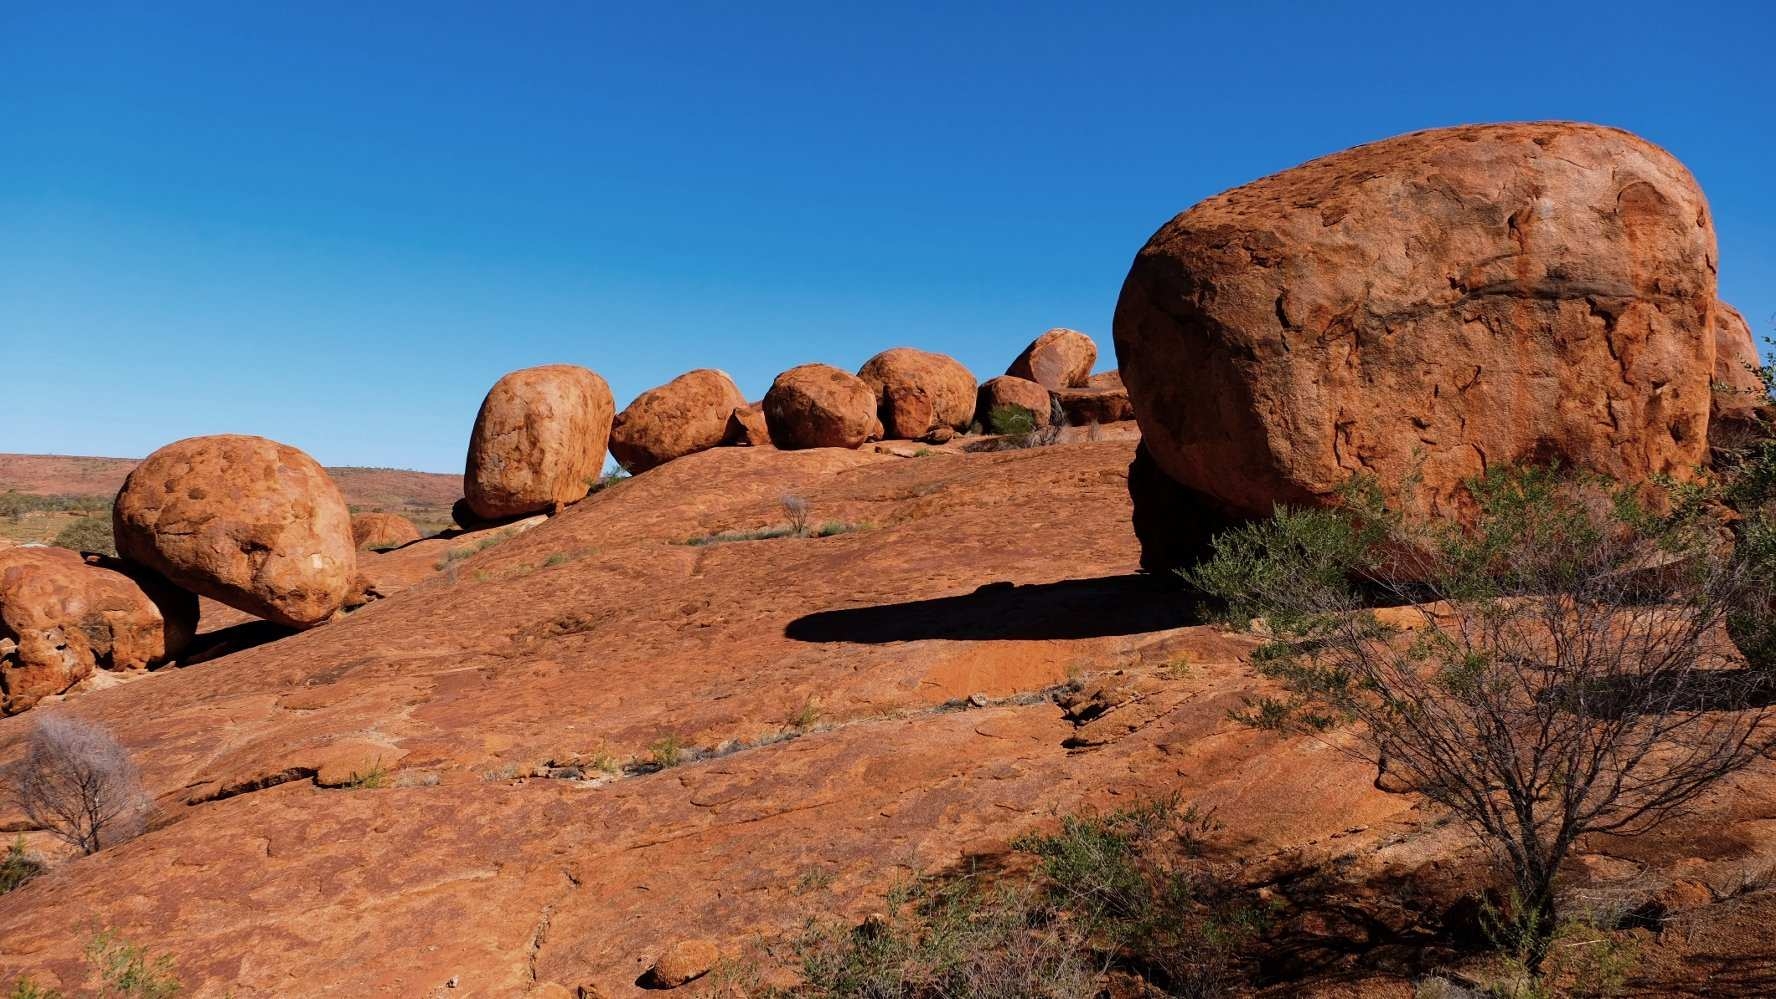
(7, 715), (151, 855)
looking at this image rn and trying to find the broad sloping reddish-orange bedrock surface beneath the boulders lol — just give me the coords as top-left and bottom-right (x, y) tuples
(0, 437), (1776, 999)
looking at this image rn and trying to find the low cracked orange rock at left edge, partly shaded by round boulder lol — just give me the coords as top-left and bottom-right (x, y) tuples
(0, 547), (197, 715)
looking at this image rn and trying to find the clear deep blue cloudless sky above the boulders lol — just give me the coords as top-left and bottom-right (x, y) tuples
(0, 0), (1776, 471)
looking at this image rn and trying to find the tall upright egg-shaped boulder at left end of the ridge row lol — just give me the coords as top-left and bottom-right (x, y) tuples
(462, 364), (616, 521)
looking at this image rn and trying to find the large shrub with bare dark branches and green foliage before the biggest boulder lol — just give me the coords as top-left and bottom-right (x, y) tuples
(1186, 468), (1776, 972)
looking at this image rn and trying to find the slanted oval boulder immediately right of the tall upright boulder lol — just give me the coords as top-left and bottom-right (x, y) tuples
(611, 368), (746, 473)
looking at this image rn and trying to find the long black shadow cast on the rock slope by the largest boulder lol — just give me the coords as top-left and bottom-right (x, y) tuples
(783, 574), (1202, 645)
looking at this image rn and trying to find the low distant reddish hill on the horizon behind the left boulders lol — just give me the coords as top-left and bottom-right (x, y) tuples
(0, 453), (462, 512)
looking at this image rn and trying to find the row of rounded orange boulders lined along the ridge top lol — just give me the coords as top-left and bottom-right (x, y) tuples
(462, 329), (1133, 521)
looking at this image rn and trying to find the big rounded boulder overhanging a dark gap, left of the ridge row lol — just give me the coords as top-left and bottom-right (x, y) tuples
(112, 434), (357, 627)
